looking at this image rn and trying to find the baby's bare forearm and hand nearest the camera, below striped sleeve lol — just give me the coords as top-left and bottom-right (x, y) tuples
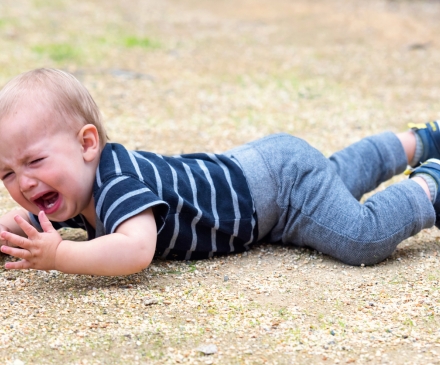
(1, 208), (157, 276)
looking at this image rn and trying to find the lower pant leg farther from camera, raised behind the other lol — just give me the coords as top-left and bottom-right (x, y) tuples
(329, 132), (407, 200)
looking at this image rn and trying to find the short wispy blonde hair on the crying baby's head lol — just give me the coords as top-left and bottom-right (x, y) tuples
(0, 68), (108, 145)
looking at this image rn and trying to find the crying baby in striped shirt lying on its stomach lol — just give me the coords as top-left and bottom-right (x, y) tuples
(0, 69), (440, 275)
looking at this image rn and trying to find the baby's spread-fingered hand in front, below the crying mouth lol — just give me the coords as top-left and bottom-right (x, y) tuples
(0, 212), (62, 270)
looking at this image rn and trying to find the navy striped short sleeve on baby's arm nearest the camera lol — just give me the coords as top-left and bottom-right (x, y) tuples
(94, 175), (169, 234)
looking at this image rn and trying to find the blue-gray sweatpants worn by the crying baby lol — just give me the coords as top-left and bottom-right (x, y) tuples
(225, 132), (435, 265)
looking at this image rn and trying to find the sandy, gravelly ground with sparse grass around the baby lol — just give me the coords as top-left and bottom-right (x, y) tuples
(0, 0), (440, 365)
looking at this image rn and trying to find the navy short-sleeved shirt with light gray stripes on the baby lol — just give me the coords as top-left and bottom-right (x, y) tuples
(31, 143), (258, 260)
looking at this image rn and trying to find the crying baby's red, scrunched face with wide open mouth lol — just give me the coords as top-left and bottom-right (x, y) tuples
(0, 105), (95, 221)
